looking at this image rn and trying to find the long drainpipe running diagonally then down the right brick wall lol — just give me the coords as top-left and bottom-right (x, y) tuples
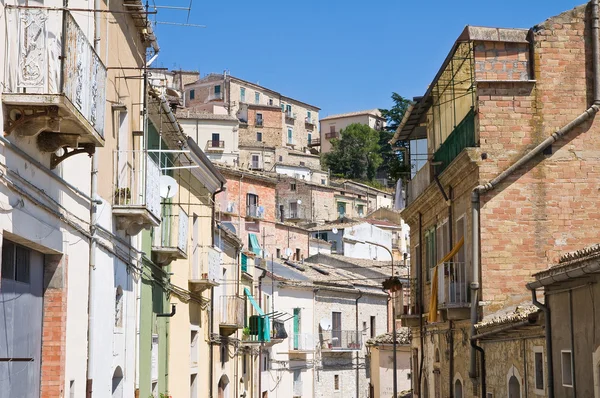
(469, 0), (600, 386)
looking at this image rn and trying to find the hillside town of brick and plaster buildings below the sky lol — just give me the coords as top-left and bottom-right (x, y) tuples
(0, 0), (600, 398)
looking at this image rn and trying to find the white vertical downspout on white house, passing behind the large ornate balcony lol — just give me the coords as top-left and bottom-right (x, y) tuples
(86, 0), (101, 398)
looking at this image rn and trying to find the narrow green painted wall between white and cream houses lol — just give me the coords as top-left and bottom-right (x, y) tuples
(139, 231), (171, 398)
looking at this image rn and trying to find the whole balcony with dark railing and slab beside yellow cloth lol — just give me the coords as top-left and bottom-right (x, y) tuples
(438, 262), (471, 320)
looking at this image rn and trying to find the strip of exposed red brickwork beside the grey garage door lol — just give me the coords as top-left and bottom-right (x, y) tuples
(40, 255), (67, 398)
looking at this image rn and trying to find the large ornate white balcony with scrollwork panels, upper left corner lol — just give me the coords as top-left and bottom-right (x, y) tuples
(2, 8), (106, 162)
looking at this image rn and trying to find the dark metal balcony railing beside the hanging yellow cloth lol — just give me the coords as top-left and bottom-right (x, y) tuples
(438, 262), (469, 307)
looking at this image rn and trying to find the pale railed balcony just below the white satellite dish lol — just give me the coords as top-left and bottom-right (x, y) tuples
(152, 205), (189, 266)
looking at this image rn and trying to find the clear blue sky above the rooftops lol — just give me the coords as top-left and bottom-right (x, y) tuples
(153, 0), (584, 117)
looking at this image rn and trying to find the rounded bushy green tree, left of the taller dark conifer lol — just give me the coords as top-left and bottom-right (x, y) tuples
(323, 123), (382, 181)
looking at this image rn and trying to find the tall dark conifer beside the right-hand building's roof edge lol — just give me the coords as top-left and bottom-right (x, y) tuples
(377, 93), (411, 181)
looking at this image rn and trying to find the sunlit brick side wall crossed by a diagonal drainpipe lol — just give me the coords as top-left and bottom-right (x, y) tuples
(479, 6), (600, 308)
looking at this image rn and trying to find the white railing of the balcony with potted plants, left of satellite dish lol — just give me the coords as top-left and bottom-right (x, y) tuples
(113, 150), (161, 219)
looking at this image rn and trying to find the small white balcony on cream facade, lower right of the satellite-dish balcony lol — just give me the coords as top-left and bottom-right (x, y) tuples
(188, 246), (221, 292)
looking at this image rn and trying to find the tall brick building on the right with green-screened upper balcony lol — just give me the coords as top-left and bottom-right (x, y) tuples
(394, 6), (600, 396)
